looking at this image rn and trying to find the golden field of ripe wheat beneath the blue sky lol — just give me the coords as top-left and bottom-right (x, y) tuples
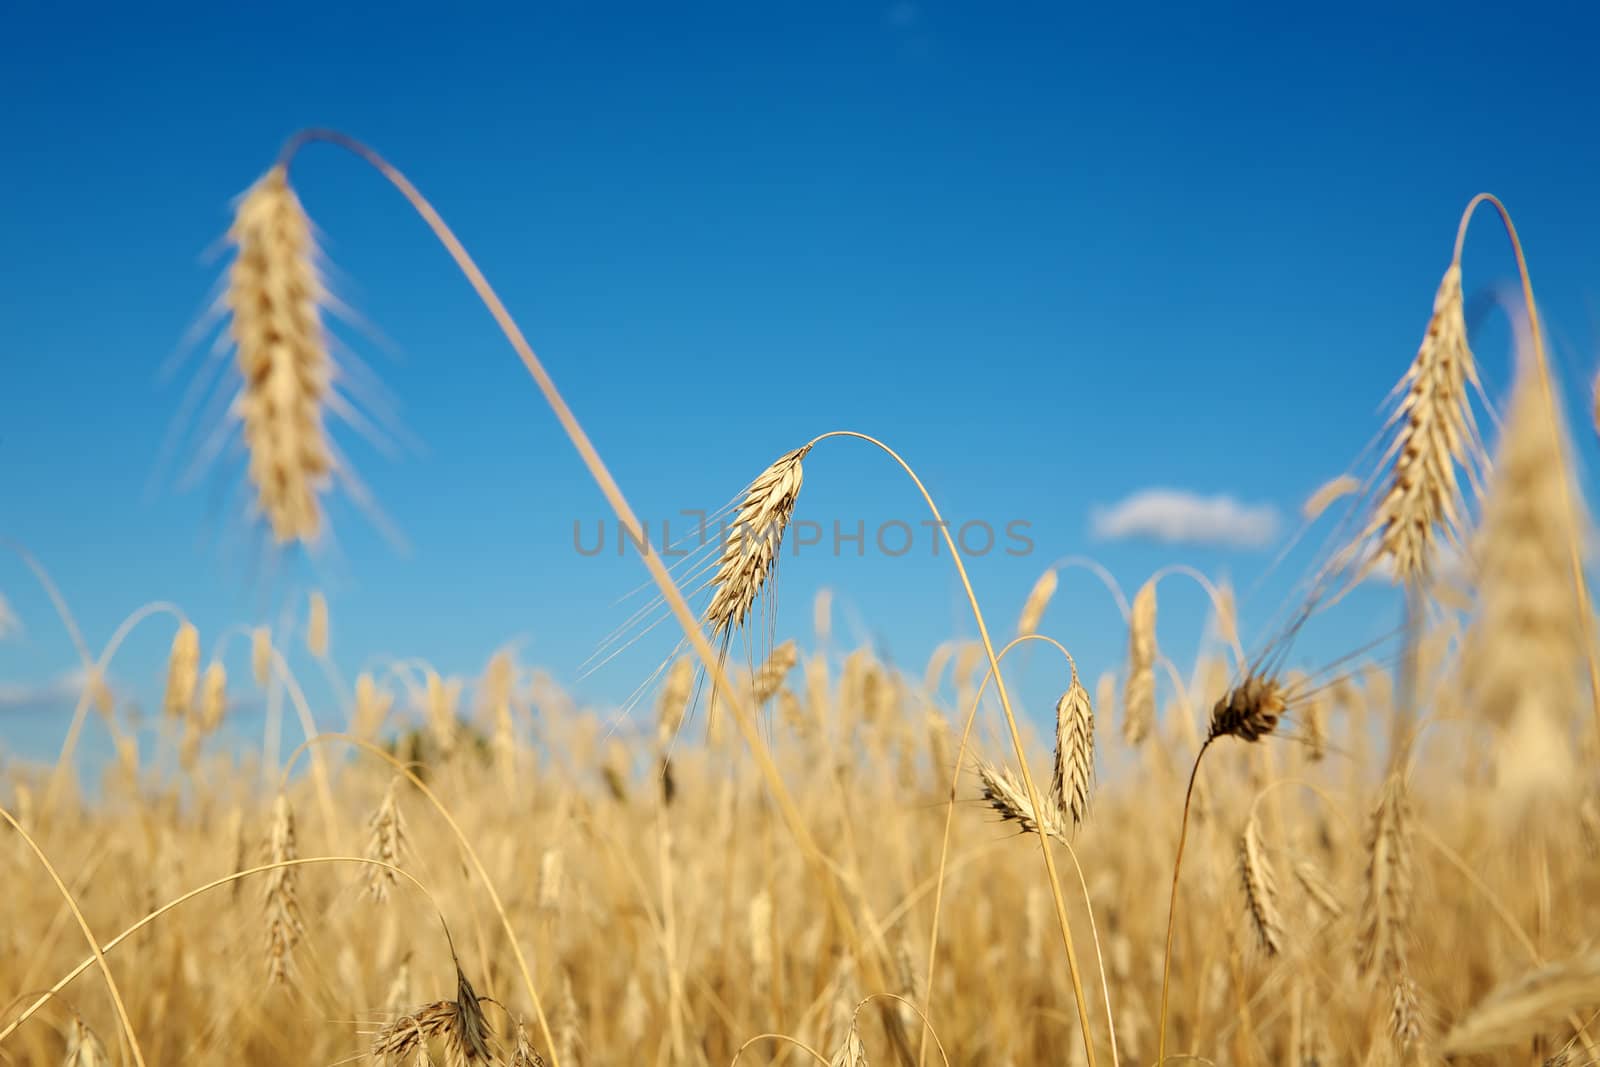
(0, 131), (1600, 1067)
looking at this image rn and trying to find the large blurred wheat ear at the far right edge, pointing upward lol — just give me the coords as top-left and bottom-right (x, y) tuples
(1461, 340), (1586, 800)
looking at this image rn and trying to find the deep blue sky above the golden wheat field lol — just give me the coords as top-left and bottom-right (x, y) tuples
(0, 0), (1600, 767)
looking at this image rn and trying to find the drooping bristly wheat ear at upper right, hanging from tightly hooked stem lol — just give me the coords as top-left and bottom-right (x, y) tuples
(1365, 259), (1478, 582)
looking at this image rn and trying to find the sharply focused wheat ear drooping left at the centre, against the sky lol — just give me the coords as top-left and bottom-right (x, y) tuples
(704, 446), (810, 643)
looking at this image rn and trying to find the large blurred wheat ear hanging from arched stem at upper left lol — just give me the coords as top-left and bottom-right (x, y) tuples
(224, 163), (334, 544)
